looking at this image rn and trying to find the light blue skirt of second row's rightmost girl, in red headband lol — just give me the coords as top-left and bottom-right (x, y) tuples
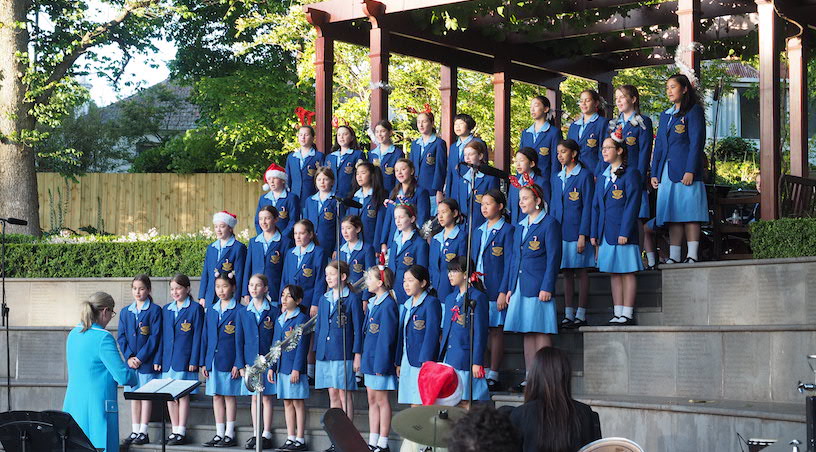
(504, 279), (558, 334)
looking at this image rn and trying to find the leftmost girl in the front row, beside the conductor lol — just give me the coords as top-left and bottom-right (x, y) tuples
(116, 274), (162, 444)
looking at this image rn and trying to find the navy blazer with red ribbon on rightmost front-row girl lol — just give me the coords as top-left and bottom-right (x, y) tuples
(439, 287), (489, 370)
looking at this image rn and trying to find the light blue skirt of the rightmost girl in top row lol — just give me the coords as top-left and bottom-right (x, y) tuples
(655, 163), (708, 226)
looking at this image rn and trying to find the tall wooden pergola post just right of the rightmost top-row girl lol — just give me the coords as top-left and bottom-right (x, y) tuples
(756, 0), (782, 220)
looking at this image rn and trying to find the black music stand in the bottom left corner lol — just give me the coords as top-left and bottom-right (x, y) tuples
(0, 411), (102, 452)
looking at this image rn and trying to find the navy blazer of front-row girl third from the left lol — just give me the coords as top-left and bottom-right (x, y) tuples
(201, 299), (242, 372)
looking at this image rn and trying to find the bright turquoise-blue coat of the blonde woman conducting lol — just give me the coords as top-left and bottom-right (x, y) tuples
(62, 323), (139, 452)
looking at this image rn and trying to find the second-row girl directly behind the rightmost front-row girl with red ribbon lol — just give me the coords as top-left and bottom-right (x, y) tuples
(428, 198), (467, 299)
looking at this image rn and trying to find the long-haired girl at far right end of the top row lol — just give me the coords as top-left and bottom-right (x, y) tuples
(651, 74), (708, 263)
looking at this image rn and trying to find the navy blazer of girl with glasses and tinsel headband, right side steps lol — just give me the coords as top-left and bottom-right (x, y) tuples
(591, 168), (643, 245)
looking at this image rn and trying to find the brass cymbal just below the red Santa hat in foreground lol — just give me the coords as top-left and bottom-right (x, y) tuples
(392, 405), (467, 447)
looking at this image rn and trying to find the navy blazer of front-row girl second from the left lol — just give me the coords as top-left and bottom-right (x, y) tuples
(159, 297), (204, 372)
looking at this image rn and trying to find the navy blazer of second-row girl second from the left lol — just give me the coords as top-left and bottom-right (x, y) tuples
(241, 233), (292, 301)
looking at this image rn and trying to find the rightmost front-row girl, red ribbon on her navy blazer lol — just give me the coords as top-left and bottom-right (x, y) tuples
(439, 256), (490, 407)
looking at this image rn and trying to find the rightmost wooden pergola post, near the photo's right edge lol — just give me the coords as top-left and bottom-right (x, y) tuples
(788, 36), (809, 177)
